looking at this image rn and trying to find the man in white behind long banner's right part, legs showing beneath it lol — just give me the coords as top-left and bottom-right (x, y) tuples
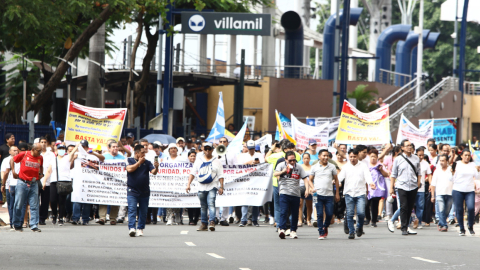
(237, 140), (265, 227)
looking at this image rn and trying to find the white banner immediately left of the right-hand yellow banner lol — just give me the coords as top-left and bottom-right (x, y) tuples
(291, 114), (329, 149)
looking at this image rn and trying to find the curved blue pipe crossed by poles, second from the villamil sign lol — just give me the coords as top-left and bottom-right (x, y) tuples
(322, 8), (363, 80)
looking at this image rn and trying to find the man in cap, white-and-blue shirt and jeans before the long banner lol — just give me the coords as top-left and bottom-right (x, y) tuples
(186, 142), (224, 232)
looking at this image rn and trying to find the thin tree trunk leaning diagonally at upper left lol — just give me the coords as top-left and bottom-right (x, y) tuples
(27, 5), (115, 114)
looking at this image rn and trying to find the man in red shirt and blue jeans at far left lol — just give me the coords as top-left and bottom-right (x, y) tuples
(10, 143), (43, 232)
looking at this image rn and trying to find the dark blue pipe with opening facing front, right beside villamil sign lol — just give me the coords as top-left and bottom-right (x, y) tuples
(280, 11), (303, 78)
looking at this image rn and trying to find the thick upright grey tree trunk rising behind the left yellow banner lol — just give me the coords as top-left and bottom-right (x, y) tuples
(85, 24), (105, 108)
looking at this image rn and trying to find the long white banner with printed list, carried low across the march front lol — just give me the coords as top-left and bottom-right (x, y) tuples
(72, 160), (273, 208)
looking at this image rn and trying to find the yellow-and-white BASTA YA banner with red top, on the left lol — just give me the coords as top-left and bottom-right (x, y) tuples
(65, 100), (127, 148)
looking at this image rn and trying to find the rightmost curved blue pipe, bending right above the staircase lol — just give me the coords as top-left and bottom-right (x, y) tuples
(395, 29), (430, 86)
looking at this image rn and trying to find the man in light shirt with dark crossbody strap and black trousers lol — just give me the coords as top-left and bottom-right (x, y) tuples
(389, 139), (422, 235)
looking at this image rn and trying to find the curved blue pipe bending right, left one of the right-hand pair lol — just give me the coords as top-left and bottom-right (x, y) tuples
(375, 24), (412, 83)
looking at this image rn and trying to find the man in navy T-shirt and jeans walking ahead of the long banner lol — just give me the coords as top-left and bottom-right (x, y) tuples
(126, 145), (158, 237)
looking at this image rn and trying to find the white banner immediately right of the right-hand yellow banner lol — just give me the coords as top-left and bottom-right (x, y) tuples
(397, 114), (433, 149)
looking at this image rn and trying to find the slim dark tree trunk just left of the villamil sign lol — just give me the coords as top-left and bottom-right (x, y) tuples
(133, 24), (158, 119)
